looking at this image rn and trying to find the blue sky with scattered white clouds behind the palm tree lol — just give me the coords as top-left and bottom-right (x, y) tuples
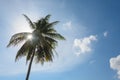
(0, 0), (120, 80)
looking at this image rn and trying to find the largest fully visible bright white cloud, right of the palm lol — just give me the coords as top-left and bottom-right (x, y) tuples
(73, 35), (97, 55)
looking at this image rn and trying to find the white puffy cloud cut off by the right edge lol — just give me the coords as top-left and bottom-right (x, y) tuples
(110, 55), (120, 79)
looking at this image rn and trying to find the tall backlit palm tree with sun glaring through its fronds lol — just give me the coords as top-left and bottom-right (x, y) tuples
(7, 14), (65, 80)
